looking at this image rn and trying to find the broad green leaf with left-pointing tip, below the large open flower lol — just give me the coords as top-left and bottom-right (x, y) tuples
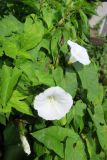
(32, 126), (78, 158)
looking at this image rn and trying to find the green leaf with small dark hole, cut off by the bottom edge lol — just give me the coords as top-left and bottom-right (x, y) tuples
(65, 137), (87, 160)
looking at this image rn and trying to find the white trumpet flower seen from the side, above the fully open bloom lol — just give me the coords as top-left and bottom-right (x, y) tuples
(67, 40), (90, 65)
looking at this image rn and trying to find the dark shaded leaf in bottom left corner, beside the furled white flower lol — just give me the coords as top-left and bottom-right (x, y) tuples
(3, 122), (23, 160)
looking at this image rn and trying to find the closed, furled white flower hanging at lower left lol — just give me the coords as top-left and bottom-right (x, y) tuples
(20, 135), (31, 155)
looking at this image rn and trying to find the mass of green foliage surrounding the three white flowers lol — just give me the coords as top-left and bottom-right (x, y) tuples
(0, 0), (107, 160)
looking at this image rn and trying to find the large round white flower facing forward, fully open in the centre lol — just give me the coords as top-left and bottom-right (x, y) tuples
(34, 86), (73, 120)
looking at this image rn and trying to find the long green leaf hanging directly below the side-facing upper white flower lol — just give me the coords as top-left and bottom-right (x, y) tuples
(75, 64), (103, 105)
